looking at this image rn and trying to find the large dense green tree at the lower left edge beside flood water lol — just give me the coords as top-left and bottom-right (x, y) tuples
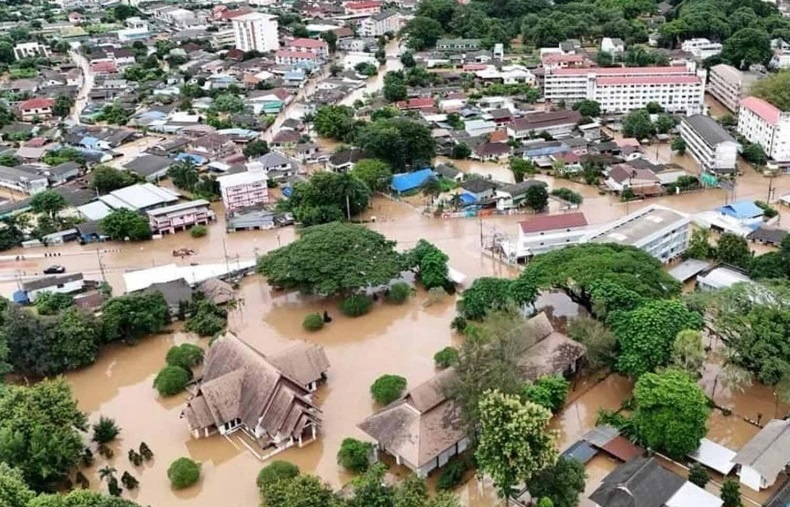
(0, 380), (87, 491)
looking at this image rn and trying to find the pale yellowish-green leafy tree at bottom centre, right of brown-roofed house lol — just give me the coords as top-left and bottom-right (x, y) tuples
(475, 391), (557, 498)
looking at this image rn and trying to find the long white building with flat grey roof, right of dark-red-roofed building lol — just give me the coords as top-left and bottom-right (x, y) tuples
(581, 205), (691, 263)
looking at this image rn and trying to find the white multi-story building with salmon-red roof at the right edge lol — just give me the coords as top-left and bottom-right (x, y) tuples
(738, 97), (790, 167)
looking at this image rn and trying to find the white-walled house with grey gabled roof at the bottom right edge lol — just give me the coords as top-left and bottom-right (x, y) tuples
(732, 419), (790, 491)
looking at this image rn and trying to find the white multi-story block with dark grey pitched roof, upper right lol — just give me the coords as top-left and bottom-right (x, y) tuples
(680, 114), (740, 173)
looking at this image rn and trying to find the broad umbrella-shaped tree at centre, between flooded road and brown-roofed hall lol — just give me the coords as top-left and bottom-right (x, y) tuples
(258, 223), (405, 295)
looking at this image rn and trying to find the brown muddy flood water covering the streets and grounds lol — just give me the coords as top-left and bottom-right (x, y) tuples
(0, 163), (790, 507)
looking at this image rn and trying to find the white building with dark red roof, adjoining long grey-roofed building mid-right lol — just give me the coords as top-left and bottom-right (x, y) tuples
(516, 212), (588, 258)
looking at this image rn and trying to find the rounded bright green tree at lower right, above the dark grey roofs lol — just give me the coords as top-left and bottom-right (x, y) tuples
(632, 369), (710, 459)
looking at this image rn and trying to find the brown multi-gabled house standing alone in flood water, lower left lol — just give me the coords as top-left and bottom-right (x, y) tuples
(181, 333), (328, 458)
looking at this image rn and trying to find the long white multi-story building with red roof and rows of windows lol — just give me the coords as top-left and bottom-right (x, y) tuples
(544, 62), (705, 114)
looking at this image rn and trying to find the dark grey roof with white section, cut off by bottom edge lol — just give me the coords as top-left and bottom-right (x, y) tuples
(590, 457), (724, 507)
